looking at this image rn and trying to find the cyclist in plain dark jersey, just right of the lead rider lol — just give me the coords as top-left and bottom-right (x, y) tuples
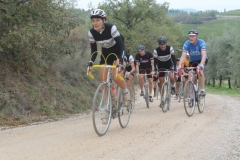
(135, 45), (154, 102)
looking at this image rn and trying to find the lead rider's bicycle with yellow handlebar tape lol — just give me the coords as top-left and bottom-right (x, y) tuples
(88, 65), (132, 136)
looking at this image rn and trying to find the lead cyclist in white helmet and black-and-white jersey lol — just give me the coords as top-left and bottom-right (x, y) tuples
(88, 9), (131, 106)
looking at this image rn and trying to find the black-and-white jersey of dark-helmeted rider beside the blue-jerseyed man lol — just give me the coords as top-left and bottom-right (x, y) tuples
(153, 45), (176, 69)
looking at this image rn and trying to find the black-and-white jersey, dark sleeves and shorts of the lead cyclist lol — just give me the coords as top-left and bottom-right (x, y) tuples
(88, 23), (124, 65)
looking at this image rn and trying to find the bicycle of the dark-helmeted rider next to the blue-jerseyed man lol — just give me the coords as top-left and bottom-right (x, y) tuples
(159, 69), (172, 113)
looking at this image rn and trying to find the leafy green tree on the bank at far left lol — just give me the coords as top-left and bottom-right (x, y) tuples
(0, 0), (80, 72)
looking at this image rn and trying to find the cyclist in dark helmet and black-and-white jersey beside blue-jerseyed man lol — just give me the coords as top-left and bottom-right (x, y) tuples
(153, 36), (177, 100)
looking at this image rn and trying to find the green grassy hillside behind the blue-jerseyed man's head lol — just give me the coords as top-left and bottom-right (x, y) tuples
(180, 19), (240, 40)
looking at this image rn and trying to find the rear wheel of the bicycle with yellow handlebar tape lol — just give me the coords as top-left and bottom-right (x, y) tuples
(118, 85), (132, 128)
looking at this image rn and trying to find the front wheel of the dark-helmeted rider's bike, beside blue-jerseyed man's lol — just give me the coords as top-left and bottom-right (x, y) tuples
(160, 82), (171, 113)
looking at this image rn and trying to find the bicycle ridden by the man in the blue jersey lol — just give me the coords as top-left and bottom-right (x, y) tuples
(183, 67), (205, 117)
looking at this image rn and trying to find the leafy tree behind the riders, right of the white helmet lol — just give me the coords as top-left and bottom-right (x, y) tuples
(99, 0), (180, 52)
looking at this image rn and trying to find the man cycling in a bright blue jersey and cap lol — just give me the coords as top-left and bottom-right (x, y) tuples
(180, 30), (207, 96)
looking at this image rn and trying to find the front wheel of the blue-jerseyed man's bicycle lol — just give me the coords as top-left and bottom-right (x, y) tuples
(183, 81), (196, 117)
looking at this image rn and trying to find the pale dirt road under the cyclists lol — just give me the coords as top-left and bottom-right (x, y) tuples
(0, 94), (240, 160)
